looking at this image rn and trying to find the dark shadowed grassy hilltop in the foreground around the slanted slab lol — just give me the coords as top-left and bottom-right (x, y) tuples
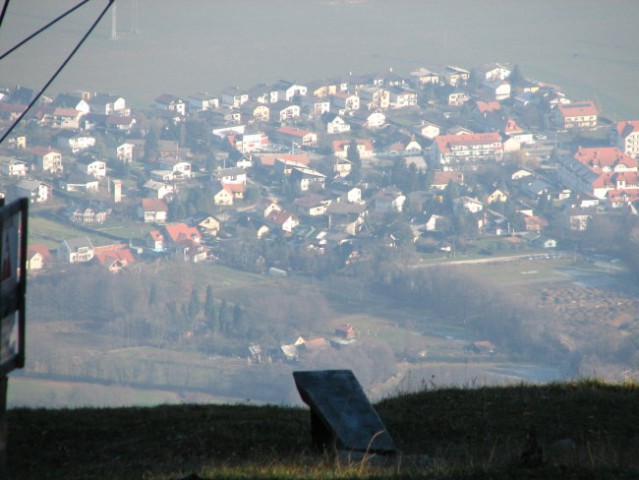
(8, 381), (639, 480)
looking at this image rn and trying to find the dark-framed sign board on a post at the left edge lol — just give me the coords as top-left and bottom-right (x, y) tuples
(0, 198), (29, 478)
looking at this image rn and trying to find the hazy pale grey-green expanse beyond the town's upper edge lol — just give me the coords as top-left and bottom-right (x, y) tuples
(0, 0), (639, 117)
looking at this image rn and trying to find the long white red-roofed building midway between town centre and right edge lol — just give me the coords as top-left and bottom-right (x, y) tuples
(430, 132), (504, 165)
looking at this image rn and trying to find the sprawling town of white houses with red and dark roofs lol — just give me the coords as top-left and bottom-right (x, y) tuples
(0, 64), (639, 276)
